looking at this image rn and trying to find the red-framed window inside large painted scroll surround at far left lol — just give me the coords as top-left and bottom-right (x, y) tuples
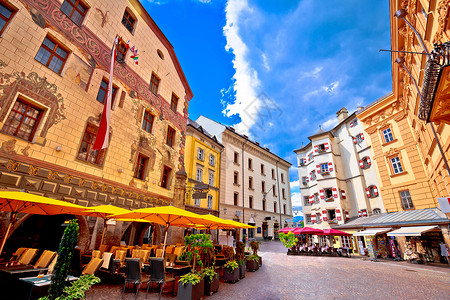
(2, 97), (42, 141)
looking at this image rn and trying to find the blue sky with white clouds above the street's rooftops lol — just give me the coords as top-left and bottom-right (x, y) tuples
(145, 0), (392, 210)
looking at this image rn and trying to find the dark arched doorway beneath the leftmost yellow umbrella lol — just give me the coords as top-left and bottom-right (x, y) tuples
(4, 215), (89, 257)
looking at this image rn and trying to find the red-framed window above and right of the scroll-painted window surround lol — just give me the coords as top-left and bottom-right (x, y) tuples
(35, 36), (69, 74)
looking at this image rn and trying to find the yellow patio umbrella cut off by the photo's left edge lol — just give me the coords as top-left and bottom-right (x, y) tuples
(0, 191), (91, 254)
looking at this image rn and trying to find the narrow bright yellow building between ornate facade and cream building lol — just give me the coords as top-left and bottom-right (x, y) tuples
(185, 119), (223, 216)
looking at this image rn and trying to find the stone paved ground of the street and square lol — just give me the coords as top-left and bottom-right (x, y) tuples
(87, 242), (450, 300)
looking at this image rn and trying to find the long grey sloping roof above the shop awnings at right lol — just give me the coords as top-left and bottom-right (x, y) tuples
(333, 208), (450, 229)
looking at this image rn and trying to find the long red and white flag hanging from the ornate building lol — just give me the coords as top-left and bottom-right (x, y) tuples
(92, 37), (118, 150)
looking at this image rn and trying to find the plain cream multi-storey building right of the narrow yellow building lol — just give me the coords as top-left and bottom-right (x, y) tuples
(196, 116), (292, 239)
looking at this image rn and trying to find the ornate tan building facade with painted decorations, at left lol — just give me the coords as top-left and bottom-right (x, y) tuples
(0, 0), (193, 252)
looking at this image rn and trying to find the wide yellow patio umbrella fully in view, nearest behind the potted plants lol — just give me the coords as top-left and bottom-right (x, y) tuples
(113, 205), (223, 257)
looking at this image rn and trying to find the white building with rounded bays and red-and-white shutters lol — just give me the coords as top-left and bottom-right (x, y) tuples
(294, 107), (385, 229)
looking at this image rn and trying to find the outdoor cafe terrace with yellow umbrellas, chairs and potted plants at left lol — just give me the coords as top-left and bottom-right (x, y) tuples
(0, 192), (261, 299)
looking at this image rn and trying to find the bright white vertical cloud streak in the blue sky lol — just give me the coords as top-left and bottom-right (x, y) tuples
(223, 0), (261, 135)
